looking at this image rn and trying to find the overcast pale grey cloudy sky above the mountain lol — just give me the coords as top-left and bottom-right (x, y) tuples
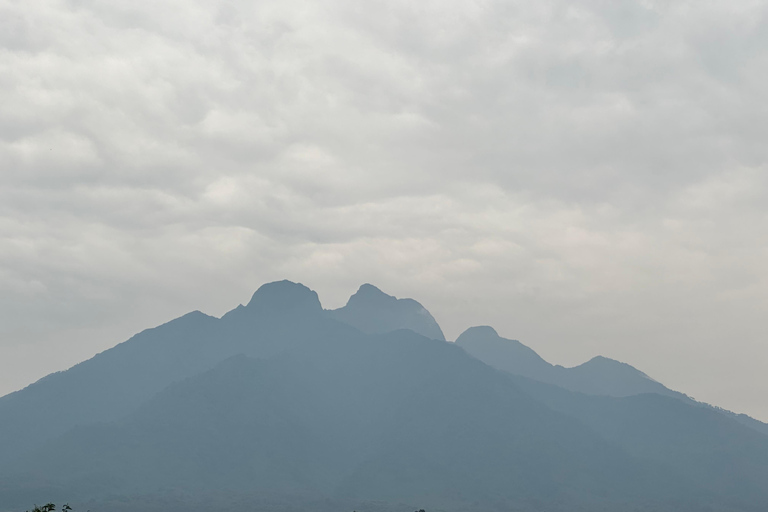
(0, 0), (768, 421)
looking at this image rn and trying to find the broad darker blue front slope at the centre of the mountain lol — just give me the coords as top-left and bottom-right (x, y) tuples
(0, 331), (716, 511)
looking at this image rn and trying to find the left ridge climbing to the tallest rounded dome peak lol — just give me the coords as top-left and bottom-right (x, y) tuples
(0, 281), (330, 465)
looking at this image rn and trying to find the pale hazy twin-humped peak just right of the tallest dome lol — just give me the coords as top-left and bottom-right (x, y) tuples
(327, 284), (445, 340)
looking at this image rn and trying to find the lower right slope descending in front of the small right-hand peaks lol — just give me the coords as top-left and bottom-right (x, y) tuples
(515, 377), (768, 510)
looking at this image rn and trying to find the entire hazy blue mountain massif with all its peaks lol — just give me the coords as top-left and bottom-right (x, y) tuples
(0, 281), (768, 512)
